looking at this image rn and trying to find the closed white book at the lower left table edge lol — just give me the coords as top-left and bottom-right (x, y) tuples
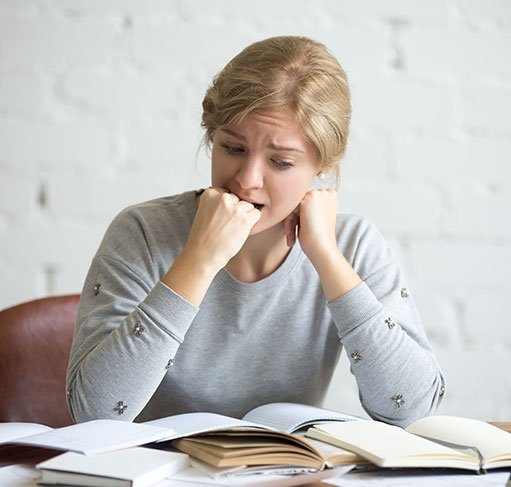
(36, 447), (190, 487)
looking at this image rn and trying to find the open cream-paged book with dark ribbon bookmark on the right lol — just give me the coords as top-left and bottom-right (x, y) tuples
(306, 416), (511, 472)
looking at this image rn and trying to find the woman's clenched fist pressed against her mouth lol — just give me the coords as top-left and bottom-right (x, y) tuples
(184, 187), (261, 270)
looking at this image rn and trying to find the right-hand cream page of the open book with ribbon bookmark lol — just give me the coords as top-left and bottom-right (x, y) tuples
(406, 416), (511, 459)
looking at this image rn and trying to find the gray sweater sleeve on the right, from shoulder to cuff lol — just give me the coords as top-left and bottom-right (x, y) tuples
(328, 216), (445, 427)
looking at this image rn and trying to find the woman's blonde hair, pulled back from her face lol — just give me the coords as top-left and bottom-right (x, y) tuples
(199, 36), (351, 188)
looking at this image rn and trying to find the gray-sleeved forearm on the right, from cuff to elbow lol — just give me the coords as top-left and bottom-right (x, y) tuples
(329, 283), (443, 426)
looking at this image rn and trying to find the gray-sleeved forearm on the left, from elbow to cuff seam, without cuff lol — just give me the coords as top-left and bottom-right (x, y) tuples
(68, 288), (180, 422)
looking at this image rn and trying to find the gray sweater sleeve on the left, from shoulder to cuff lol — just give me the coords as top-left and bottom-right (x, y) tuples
(67, 209), (198, 422)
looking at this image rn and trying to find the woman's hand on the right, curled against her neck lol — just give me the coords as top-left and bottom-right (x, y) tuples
(284, 189), (339, 264)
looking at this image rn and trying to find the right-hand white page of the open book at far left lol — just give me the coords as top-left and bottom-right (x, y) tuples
(10, 419), (174, 454)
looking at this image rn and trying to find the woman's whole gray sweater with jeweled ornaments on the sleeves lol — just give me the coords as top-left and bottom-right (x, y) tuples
(67, 191), (444, 426)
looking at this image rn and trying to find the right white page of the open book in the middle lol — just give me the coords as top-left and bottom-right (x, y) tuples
(243, 402), (360, 433)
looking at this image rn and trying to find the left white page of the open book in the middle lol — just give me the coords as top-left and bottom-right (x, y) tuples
(141, 413), (271, 441)
